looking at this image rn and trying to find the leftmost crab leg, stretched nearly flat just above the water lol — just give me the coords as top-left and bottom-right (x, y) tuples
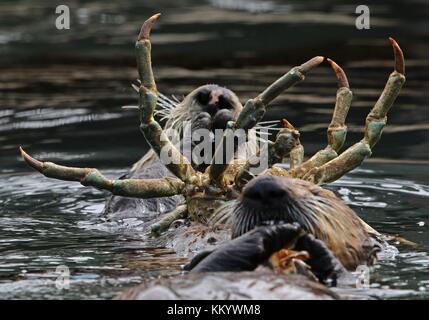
(19, 147), (185, 199)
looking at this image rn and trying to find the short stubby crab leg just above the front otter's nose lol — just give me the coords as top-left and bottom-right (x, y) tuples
(235, 119), (300, 190)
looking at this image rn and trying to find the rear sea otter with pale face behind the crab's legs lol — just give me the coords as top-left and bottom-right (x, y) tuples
(104, 84), (246, 221)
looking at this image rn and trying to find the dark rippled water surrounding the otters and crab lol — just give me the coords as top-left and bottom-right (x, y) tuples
(0, 1), (429, 299)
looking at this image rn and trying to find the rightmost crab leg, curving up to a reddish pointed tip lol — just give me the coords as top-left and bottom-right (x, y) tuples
(303, 38), (405, 184)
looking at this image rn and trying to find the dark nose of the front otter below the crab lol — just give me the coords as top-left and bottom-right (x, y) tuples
(243, 177), (288, 207)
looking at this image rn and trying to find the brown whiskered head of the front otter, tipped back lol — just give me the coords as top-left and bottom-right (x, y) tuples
(232, 176), (379, 269)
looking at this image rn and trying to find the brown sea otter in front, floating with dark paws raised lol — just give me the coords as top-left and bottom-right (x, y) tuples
(118, 175), (382, 299)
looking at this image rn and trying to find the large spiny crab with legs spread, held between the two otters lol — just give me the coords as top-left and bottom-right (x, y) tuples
(20, 14), (405, 248)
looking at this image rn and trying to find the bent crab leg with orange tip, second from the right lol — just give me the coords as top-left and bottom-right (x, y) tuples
(290, 59), (352, 178)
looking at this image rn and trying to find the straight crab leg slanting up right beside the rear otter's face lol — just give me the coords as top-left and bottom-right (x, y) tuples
(208, 56), (324, 185)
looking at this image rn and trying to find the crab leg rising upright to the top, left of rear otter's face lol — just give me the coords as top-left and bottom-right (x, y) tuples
(136, 13), (199, 182)
